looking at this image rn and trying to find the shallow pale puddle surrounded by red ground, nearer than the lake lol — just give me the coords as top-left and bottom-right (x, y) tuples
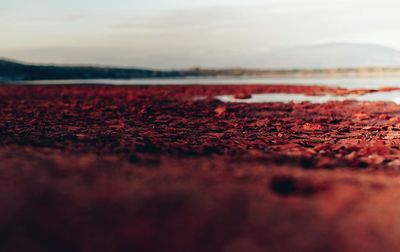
(217, 90), (400, 104)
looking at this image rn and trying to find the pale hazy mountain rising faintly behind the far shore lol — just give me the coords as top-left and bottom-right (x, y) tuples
(258, 43), (400, 69)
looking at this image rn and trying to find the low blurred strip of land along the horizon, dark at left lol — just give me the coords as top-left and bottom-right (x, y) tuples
(0, 57), (400, 82)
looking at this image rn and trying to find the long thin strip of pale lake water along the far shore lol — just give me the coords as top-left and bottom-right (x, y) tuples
(22, 76), (400, 89)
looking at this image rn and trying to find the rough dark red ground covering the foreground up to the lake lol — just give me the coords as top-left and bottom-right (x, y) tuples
(0, 86), (400, 252)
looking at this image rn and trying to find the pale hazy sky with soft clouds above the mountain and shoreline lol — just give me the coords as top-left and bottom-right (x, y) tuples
(0, 0), (400, 68)
